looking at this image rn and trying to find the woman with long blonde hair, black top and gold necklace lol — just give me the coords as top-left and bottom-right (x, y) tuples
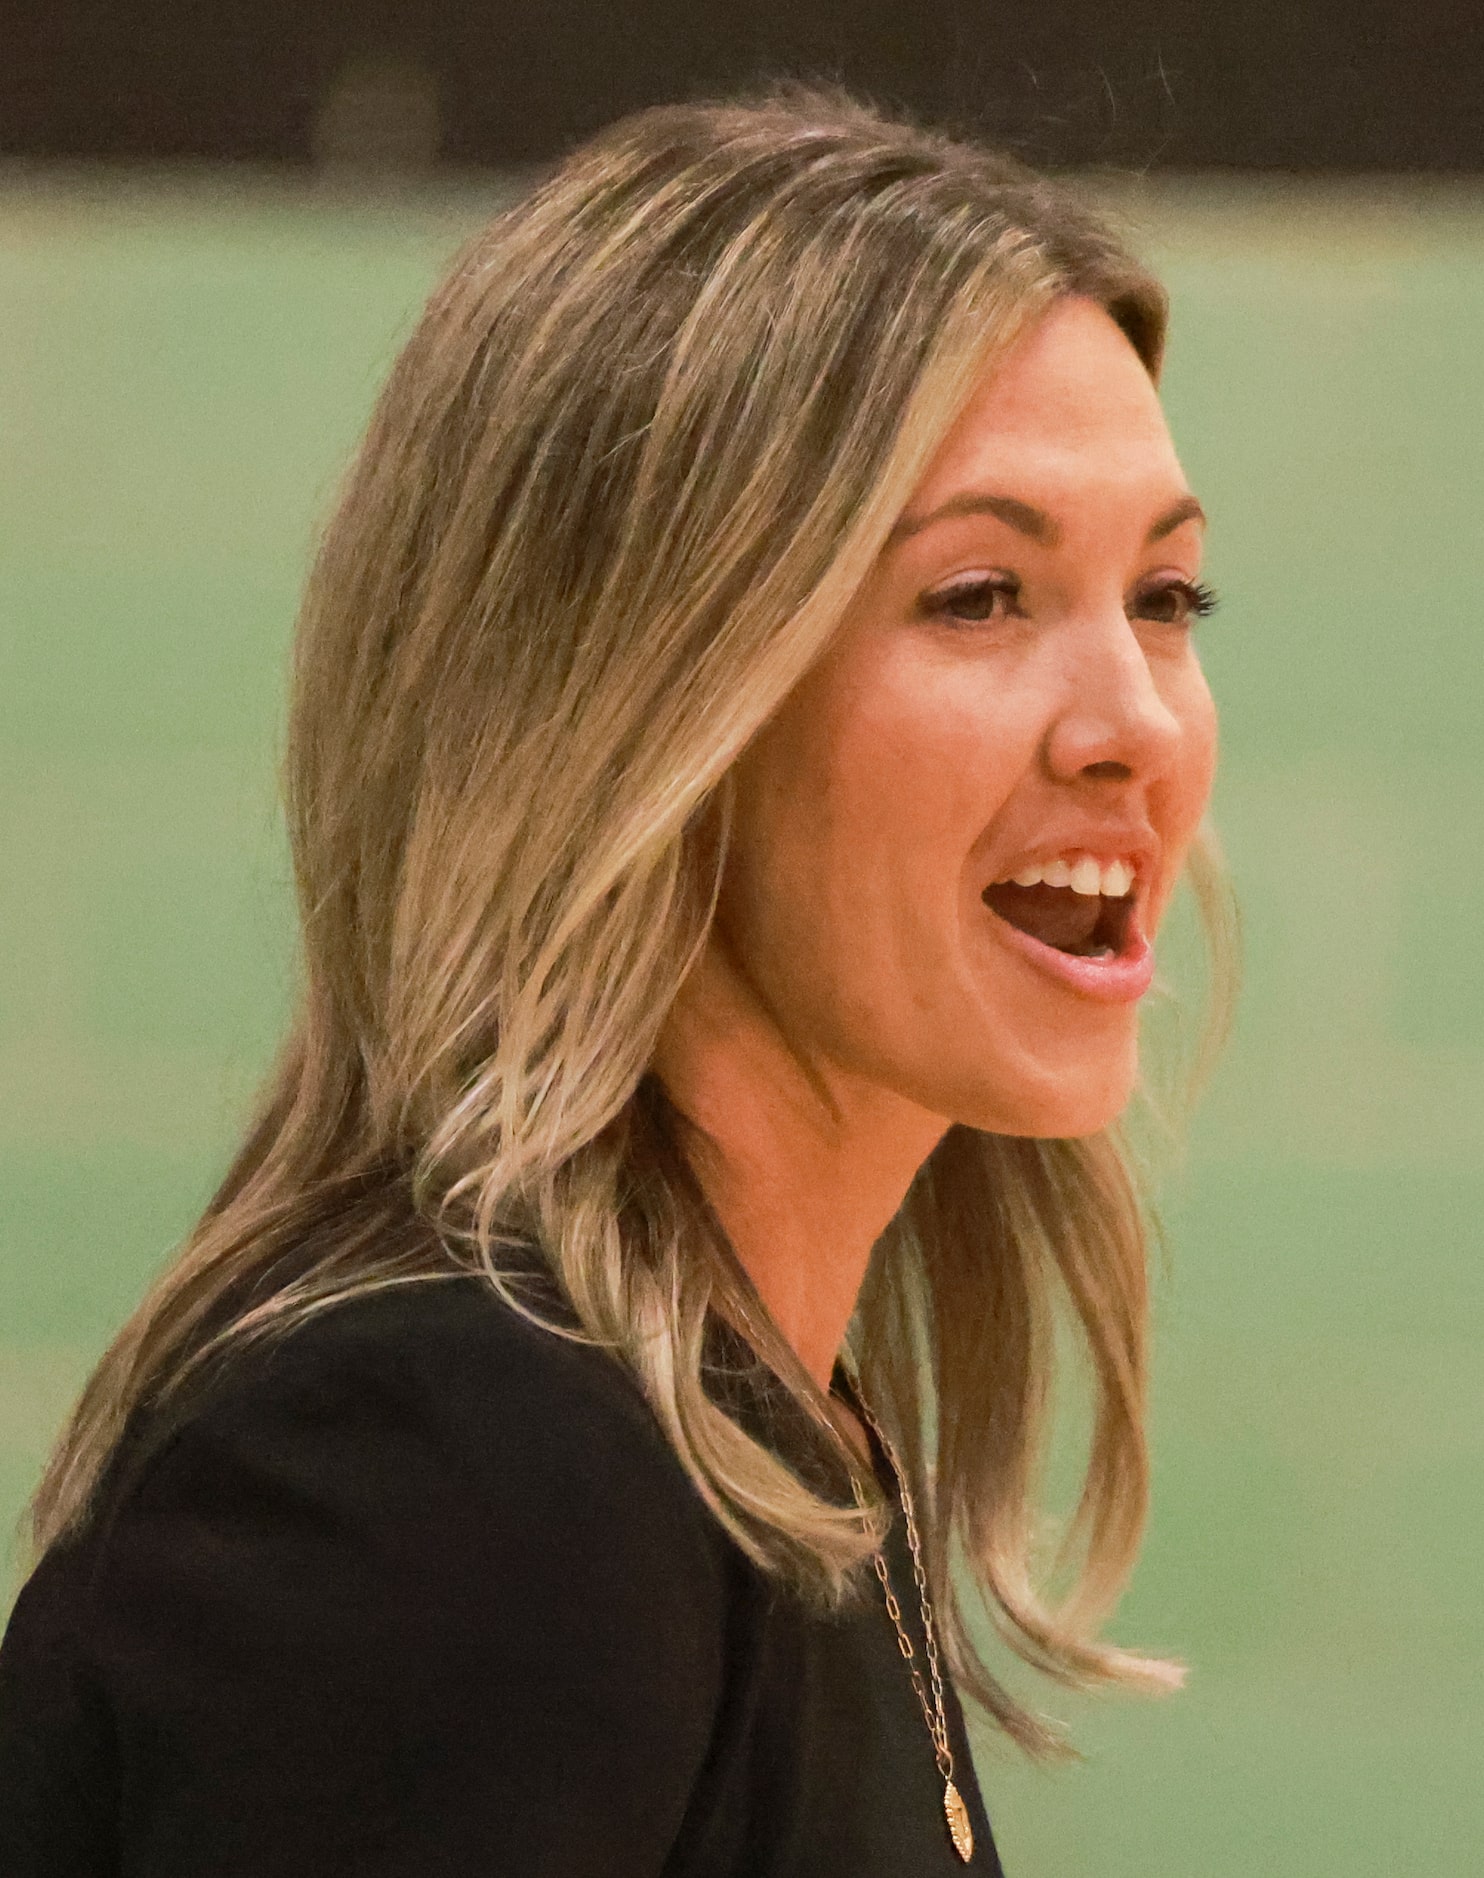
(0, 94), (1213, 1878)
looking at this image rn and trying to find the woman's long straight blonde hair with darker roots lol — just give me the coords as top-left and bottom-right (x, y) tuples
(34, 92), (1239, 1750)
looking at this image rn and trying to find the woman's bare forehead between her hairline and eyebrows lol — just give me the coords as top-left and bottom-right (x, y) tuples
(909, 299), (1183, 513)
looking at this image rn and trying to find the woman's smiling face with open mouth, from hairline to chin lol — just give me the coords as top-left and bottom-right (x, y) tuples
(718, 299), (1215, 1136)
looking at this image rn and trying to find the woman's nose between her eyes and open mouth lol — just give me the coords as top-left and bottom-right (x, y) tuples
(1044, 607), (1182, 783)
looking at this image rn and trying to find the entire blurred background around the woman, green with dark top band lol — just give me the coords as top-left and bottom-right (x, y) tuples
(0, 0), (1484, 1878)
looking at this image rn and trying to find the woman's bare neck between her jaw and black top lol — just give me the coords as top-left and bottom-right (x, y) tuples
(654, 935), (947, 1390)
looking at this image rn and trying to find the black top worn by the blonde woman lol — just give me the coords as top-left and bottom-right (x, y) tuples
(0, 1279), (999, 1878)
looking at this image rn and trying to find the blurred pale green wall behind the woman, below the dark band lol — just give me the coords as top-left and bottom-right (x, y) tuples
(0, 180), (1484, 1878)
